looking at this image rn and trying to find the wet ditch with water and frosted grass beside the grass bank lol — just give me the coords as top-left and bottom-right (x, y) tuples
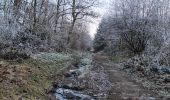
(54, 56), (95, 100)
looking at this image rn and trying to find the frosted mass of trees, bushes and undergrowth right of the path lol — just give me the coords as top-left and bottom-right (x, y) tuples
(94, 0), (170, 94)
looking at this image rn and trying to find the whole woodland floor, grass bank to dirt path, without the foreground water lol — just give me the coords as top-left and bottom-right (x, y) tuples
(0, 53), (165, 100)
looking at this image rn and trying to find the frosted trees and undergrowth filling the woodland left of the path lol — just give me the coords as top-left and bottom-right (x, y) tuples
(0, 0), (97, 58)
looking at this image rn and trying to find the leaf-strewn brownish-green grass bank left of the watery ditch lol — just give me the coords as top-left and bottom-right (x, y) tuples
(0, 52), (72, 100)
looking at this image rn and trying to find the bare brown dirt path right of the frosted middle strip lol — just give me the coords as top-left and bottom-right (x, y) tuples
(94, 54), (156, 100)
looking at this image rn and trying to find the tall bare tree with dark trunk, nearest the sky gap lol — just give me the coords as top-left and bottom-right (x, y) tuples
(67, 0), (96, 48)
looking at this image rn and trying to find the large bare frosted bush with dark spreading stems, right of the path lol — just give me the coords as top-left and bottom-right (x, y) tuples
(94, 0), (170, 54)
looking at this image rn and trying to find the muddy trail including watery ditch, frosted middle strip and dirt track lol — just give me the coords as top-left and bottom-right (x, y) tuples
(53, 54), (159, 100)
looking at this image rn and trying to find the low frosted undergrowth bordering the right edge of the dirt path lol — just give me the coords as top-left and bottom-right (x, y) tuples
(121, 55), (170, 96)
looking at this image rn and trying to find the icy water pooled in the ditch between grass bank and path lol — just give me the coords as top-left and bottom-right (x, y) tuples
(55, 56), (95, 100)
